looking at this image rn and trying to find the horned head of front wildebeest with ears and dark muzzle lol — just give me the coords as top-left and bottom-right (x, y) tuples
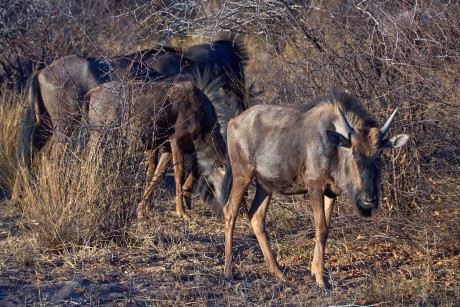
(327, 109), (409, 217)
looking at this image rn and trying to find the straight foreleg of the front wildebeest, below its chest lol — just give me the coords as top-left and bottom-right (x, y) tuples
(309, 189), (332, 288)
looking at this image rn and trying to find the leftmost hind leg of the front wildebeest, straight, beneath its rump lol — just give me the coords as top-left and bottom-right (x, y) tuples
(224, 173), (251, 278)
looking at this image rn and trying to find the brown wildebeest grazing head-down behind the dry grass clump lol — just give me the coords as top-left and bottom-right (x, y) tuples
(87, 80), (227, 217)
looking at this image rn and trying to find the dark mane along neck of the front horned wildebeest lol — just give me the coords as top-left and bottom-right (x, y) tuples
(299, 89), (377, 129)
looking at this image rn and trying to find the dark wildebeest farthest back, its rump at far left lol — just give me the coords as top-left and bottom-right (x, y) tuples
(13, 33), (247, 214)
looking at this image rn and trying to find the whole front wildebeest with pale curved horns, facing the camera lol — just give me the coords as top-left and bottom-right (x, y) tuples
(222, 91), (409, 287)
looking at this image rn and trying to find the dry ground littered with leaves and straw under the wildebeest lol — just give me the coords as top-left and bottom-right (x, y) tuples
(0, 189), (460, 306)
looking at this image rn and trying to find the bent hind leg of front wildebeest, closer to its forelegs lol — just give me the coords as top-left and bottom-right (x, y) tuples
(249, 185), (283, 277)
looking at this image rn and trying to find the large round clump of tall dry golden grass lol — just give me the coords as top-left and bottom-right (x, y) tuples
(19, 142), (143, 253)
